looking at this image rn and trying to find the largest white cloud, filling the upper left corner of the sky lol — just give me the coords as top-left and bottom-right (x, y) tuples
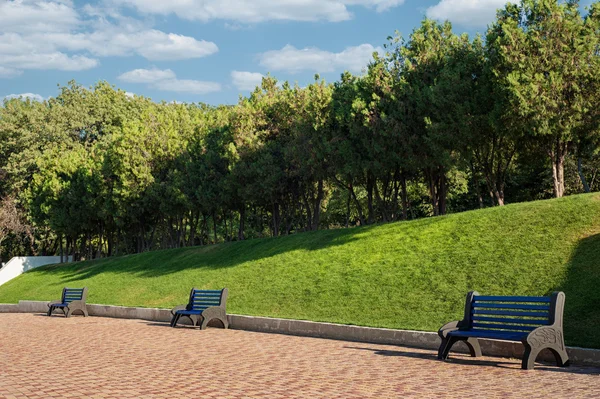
(0, 0), (219, 78)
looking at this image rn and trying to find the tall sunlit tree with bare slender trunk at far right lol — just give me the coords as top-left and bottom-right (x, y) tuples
(487, 0), (600, 197)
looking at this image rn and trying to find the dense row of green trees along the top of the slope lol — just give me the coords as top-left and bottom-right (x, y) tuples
(0, 0), (600, 259)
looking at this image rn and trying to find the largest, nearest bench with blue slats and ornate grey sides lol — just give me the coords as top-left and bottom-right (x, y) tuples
(438, 291), (569, 370)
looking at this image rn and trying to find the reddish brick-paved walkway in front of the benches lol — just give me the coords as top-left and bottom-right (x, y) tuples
(0, 314), (600, 399)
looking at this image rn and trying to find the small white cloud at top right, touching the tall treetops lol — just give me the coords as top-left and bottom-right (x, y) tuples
(426, 0), (508, 28)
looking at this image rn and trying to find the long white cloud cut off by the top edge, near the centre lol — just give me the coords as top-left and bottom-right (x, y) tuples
(111, 0), (404, 23)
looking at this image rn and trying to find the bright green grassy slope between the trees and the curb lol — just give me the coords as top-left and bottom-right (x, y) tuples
(0, 194), (600, 348)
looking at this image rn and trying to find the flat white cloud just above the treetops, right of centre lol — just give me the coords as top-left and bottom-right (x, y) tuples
(260, 44), (382, 73)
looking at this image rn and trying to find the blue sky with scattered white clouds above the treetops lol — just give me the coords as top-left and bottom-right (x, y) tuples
(0, 0), (592, 104)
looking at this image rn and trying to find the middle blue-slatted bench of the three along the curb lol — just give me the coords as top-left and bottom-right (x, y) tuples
(171, 288), (229, 330)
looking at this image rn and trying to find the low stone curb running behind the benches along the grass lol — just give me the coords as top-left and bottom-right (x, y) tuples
(0, 301), (600, 366)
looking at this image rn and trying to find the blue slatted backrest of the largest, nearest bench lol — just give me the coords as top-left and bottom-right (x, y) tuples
(465, 291), (565, 333)
